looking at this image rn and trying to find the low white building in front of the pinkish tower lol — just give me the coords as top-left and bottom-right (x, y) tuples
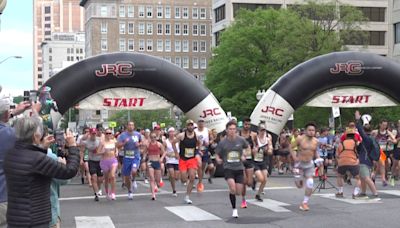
(41, 32), (85, 82)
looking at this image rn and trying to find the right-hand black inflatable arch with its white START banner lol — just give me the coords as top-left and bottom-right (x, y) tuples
(251, 52), (400, 135)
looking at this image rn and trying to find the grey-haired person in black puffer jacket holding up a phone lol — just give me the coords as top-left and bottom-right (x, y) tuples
(4, 116), (79, 228)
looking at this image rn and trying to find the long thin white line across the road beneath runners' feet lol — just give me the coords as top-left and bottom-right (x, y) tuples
(59, 187), (295, 201)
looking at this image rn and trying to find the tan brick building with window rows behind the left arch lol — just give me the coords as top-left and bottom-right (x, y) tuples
(80, 0), (212, 80)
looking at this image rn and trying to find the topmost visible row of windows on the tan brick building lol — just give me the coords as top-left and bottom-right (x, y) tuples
(116, 5), (207, 19)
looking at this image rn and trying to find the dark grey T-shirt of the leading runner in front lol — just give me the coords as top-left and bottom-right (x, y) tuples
(215, 136), (249, 170)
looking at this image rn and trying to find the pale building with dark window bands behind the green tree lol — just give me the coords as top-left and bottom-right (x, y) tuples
(212, 0), (394, 60)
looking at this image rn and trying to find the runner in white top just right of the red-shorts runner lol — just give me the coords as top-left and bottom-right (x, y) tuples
(194, 119), (210, 192)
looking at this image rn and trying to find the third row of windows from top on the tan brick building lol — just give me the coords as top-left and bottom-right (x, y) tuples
(115, 39), (207, 52)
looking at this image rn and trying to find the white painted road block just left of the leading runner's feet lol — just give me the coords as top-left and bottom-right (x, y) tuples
(165, 206), (221, 221)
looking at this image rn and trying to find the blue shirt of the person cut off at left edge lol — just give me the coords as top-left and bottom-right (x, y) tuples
(0, 123), (17, 203)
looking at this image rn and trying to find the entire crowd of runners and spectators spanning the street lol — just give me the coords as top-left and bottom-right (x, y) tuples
(0, 87), (400, 227)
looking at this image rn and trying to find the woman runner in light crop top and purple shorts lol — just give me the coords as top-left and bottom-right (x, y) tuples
(97, 129), (118, 200)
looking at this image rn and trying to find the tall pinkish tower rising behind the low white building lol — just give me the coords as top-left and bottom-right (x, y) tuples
(33, 0), (84, 89)
